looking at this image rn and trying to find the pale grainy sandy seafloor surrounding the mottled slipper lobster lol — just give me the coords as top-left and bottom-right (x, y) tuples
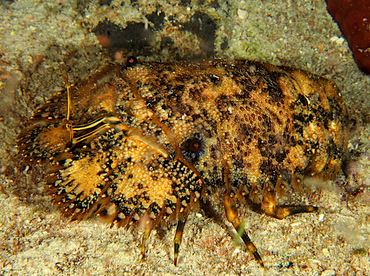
(0, 0), (370, 276)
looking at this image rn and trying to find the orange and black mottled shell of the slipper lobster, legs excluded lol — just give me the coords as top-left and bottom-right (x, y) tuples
(18, 60), (348, 249)
